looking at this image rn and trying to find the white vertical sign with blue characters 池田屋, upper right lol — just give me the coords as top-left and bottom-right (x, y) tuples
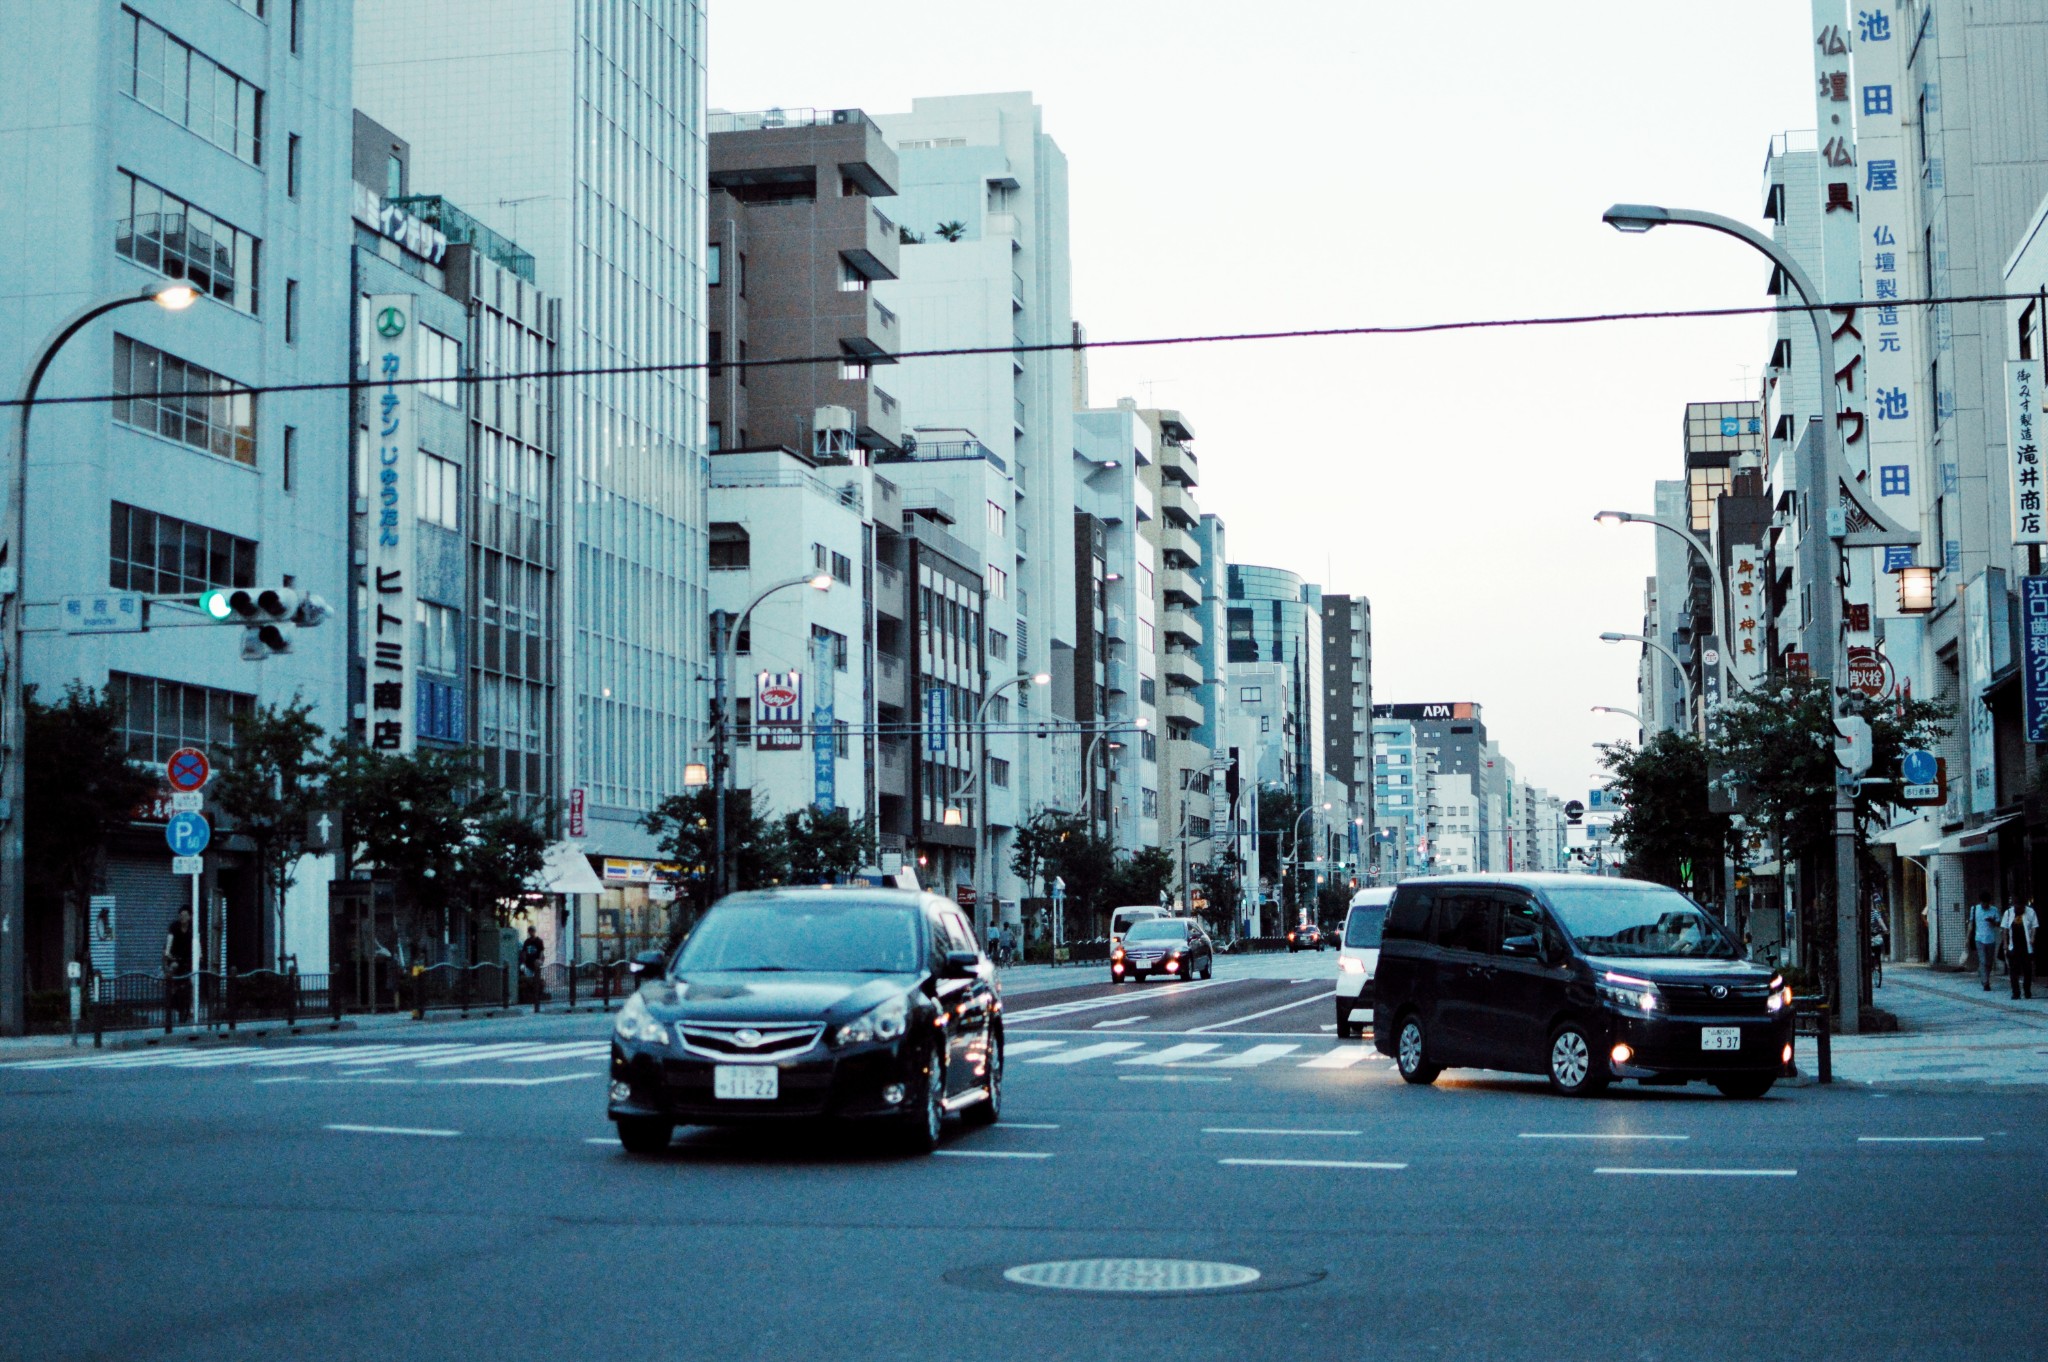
(1853, 0), (1929, 619)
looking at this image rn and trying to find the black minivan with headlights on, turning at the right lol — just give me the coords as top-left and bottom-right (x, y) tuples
(1372, 875), (1792, 1098)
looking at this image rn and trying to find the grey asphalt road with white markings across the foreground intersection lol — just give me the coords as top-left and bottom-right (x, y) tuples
(0, 952), (2048, 1362)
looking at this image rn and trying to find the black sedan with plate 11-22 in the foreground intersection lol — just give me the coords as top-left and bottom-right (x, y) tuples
(608, 887), (1004, 1153)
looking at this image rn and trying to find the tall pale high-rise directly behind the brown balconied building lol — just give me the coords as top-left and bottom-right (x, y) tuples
(872, 94), (1081, 864)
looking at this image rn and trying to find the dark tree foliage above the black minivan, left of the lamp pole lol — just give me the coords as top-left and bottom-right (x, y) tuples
(1599, 731), (1745, 899)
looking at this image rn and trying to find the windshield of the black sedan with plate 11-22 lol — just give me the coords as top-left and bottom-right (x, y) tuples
(676, 903), (920, 975)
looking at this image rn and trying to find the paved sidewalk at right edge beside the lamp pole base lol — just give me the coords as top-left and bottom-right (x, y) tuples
(1833, 965), (2048, 1086)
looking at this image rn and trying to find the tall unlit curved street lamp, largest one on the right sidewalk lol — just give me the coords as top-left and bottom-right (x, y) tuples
(1602, 203), (1921, 1034)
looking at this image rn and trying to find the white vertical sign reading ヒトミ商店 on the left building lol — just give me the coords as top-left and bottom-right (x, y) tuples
(362, 293), (420, 752)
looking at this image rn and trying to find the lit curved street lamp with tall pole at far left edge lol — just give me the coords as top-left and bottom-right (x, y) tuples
(0, 281), (199, 1036)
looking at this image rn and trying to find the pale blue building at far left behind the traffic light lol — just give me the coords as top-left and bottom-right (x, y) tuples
(0, 0), (350, 999)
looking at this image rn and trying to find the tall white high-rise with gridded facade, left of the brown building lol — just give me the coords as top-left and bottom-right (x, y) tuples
(354, 0), (711, 856)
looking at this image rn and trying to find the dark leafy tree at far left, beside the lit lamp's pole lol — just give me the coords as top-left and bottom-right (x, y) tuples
(23, 682), (156, 961)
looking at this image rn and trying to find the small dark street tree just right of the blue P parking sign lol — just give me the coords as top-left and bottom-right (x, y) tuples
(211, 696), (328, 971)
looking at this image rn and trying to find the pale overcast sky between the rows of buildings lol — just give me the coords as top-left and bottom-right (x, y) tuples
(709, 0), (1815, 797)
